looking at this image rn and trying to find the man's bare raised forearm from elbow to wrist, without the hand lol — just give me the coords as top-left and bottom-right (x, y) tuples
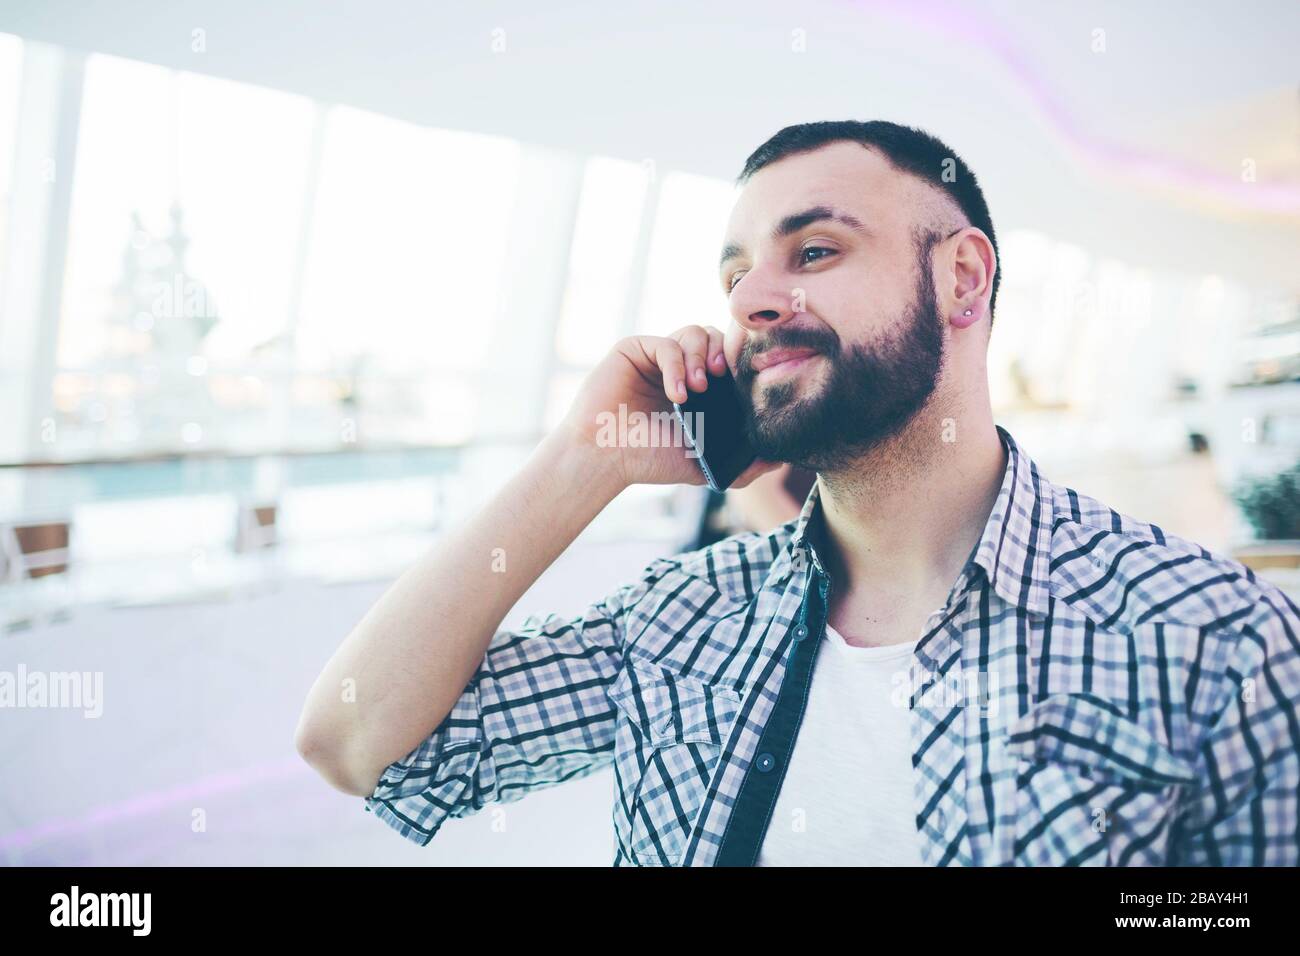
(296, 432), (623, 796)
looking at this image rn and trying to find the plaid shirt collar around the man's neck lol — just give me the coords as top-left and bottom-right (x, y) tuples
(771, 425), (1053, 614)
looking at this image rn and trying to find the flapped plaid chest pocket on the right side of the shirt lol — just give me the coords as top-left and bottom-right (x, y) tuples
(1008, 693), (1196, 866)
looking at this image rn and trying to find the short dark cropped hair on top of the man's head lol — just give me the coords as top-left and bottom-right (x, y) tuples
(736, 120), (1002, 328)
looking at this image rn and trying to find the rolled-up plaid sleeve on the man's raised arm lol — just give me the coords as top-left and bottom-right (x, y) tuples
(364, 579), (646, 845)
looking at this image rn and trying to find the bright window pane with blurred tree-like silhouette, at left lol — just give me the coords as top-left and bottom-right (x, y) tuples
(53, 56), (312, 457)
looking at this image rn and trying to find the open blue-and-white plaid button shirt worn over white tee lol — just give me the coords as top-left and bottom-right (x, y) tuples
(365, 427), (1300, 866)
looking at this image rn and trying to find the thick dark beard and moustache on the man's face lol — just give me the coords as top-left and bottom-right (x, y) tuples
(736, 250), (944, 472)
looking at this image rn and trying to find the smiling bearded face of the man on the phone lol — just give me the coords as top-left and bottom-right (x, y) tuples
(720, 142), (944, 471)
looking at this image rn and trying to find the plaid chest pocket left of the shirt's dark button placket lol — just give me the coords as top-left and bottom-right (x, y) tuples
(610, 658), (741, 866)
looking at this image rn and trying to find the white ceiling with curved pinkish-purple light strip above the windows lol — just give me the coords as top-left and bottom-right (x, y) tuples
(0, 0), (1300, 293)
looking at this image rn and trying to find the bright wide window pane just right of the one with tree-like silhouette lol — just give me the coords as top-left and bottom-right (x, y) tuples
(295, 108), (520, 442)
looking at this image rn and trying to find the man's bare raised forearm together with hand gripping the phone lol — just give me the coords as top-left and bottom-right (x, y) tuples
(296, 326), (775, 796)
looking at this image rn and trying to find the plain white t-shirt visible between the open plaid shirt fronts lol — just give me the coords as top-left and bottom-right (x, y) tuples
(757, 624), (923, 866)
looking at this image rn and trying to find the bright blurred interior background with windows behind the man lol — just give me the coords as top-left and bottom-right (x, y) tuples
(0, 0), (1300, 866)
